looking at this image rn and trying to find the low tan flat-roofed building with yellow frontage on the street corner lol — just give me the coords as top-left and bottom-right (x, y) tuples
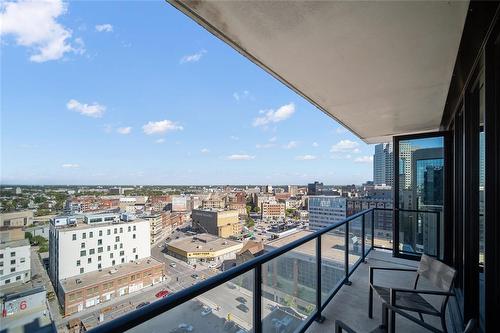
(167, 233), (243, 264)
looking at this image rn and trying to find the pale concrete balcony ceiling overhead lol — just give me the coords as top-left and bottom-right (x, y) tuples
(169, 0), (469, 143)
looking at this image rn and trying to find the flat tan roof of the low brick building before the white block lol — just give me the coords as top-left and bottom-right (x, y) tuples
(59, 257), (164, 292)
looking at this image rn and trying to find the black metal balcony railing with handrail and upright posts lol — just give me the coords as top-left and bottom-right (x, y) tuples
(91, 208), (438, 333)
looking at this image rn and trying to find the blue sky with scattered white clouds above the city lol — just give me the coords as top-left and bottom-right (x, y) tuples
(0, 1), (373, 184)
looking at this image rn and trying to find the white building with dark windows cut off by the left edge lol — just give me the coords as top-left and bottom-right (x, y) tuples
(0, 239), (31, 288)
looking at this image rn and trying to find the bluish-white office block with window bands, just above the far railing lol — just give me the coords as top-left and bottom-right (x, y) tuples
(308, 196), (347, 231)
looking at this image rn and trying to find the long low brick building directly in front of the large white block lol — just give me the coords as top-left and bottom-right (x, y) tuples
(58, 258), (165, 315)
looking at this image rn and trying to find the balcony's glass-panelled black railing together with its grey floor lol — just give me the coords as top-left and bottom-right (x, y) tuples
(93, 208), (450, 332)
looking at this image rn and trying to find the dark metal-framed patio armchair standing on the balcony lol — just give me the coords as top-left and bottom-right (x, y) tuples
(368, 254), (456, 333)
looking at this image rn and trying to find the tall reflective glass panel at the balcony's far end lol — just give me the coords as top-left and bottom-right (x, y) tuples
(399, 137), (444, 255)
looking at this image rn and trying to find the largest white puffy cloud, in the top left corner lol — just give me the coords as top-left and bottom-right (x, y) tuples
(0, 0), (85, 62)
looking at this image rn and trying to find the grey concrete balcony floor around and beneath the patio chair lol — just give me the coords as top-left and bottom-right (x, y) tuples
(307, 250), (454, 333)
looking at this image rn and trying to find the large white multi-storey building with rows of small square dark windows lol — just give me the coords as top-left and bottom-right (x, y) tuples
(49, 214), (151, 289)
